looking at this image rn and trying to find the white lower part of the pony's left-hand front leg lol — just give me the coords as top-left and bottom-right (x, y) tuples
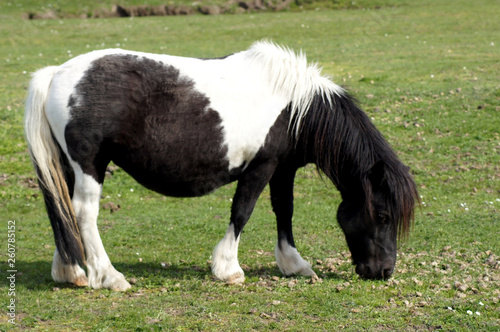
(212, 225), (245, 284)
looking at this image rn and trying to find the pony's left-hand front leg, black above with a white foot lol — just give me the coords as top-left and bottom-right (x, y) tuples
(212, 164), (274, 284)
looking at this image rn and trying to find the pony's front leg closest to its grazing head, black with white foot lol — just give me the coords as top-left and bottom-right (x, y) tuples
(269, 169), (316, 277)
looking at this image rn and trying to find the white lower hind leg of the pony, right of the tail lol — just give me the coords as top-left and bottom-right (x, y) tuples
(72, 172), (131, 291)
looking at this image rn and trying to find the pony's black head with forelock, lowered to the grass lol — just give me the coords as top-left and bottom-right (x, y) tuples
(337, 161), (416, 279)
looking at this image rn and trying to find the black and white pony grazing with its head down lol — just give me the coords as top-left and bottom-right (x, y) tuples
(25, 42), (418, 290)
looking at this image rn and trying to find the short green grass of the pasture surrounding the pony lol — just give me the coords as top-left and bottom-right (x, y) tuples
(0, 0), (500, 331)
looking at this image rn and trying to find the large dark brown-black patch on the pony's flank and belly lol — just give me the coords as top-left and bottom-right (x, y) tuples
(65, 55), (241, 197)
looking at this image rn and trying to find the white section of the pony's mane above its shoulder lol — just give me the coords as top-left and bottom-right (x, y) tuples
(248, 41), (344, 135)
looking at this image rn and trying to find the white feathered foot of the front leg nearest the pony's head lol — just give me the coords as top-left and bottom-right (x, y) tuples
(275, 240), (316, 277)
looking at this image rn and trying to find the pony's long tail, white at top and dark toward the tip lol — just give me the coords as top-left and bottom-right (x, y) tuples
(24, 67), (85, 264)
